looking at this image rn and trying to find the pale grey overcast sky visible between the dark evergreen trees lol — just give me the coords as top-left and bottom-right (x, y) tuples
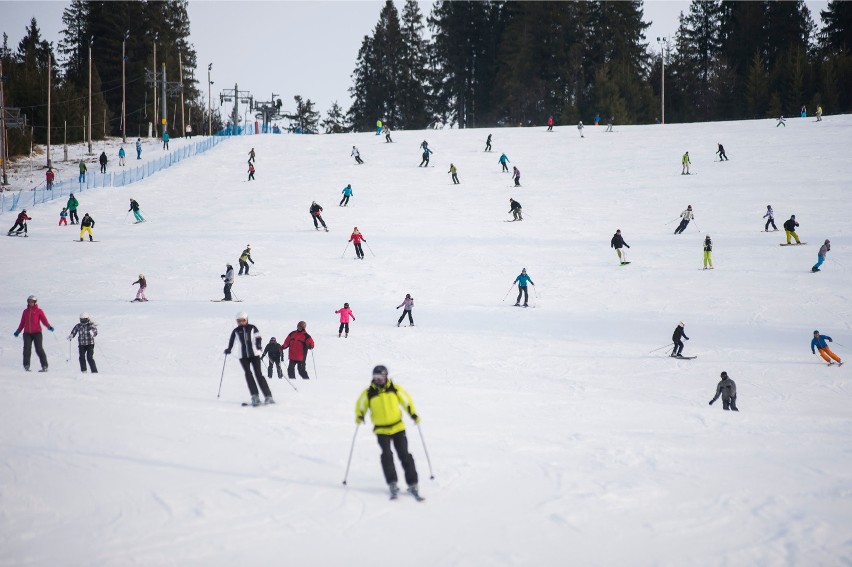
(0, 0), (828, 115)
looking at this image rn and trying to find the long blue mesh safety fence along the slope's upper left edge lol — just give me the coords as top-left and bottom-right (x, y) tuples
(0, 136), (227, 213)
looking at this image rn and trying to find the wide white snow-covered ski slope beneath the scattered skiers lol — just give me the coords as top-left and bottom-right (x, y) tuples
(5, 116), (852, 567)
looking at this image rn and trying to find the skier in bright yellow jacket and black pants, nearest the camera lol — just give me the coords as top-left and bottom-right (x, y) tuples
(355, 364), (420, 499)
